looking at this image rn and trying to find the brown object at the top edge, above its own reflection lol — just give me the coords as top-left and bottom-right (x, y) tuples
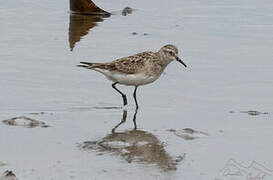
(70, 0), (111, 17)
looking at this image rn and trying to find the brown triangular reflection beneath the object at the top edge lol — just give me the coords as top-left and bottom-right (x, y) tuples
(69, 14), (103, 51)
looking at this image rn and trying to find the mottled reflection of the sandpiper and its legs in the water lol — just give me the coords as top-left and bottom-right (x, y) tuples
(79, 110), (185, 171)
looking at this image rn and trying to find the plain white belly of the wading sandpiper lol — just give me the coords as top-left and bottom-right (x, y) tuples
(108, 73), (158, 86)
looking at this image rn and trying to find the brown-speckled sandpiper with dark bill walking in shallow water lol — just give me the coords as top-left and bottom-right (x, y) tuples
(78, 44), (187, 109)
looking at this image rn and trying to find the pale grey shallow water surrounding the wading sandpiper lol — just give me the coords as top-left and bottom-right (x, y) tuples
(0, 0), (273, 180)
